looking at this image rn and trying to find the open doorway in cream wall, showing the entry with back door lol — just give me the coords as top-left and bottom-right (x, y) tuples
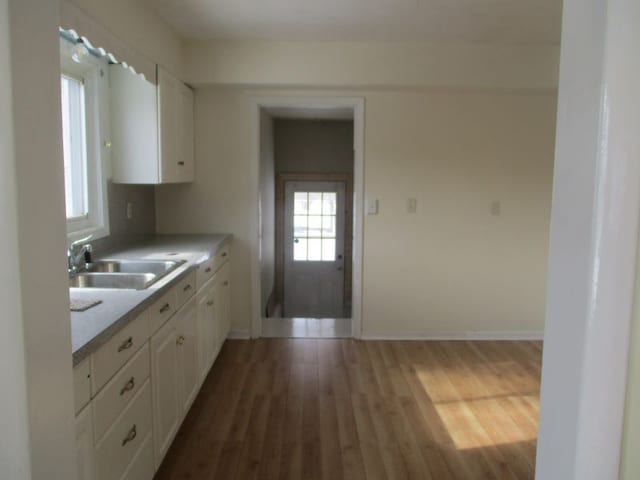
(251, 98), (363, 338)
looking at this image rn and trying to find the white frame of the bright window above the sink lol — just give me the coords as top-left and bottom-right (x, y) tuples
(60, 38), (110, 242)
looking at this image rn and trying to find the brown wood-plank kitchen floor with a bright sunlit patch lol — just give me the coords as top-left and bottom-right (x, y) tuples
(156, 339), (542, 480)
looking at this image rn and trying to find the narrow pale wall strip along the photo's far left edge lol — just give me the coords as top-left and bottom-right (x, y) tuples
(0, 0), (31, 480)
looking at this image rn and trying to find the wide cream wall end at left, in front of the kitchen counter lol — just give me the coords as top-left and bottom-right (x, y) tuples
(8, 0), (75, 479)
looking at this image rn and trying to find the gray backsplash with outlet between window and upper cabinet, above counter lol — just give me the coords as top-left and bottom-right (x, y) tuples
(91, 181), (156, 257)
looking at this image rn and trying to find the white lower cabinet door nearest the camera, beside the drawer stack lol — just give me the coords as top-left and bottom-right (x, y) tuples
(151, 316), (182, 468)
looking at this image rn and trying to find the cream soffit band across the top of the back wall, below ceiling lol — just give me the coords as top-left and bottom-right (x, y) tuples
(185, 41), (559, 91)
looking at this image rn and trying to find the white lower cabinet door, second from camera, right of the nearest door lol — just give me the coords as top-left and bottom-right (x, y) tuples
(176, 298), (200, 414)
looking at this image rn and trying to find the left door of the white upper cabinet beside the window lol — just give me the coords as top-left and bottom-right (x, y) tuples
(158, 67), (181, 183)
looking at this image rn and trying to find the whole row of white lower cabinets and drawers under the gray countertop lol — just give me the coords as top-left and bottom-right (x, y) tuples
(74, 245), (231, 480)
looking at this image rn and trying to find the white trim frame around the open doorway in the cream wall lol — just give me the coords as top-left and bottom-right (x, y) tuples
(248, 95), (365, 338)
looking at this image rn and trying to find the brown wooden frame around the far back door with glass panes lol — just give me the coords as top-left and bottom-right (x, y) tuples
(275, 172), (353, 318)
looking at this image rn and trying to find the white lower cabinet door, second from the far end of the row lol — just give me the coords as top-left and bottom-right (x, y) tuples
(196, 281), (217, 382)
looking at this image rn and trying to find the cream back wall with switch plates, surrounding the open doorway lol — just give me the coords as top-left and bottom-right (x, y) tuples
(157, 88), (556, 336)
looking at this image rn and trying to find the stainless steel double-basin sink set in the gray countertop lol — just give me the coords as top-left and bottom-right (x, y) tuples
(69, 260), (185, 290)
